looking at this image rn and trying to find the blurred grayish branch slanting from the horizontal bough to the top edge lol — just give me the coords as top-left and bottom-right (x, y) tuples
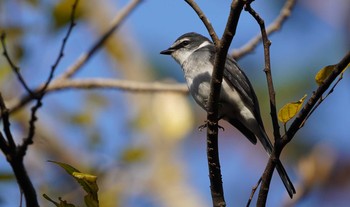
(58, 0), (143, 79)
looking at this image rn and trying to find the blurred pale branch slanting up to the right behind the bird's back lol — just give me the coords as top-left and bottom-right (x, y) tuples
(232, 0), (296, 60)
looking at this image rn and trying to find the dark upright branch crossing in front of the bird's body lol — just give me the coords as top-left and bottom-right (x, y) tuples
(207, 0), (245, 206)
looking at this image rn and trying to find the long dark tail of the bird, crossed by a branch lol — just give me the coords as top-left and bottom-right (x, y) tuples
(258, 129), (296, 198)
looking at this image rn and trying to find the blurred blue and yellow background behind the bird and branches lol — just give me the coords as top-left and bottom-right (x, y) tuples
(0, 0), (350, 207)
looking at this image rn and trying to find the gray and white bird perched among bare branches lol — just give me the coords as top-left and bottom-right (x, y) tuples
(160, 32), (295, 197)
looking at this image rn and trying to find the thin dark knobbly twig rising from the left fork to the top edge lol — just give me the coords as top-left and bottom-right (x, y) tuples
(18, 0), (79, 156)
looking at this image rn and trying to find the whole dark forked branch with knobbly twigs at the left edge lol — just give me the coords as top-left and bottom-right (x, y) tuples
(0, 0), (78, 207)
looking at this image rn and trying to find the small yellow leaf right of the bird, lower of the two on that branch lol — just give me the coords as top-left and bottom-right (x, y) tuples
(278, 94), (307, 124)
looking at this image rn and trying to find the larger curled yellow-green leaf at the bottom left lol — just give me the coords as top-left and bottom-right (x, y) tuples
(49, 161), (99, 207)
